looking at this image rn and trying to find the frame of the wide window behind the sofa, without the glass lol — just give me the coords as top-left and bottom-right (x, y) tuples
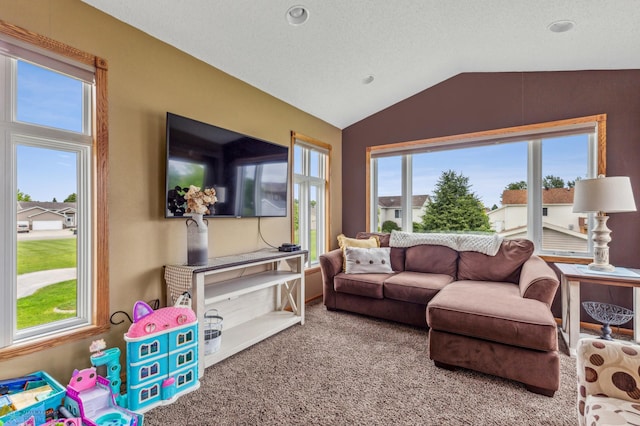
(367, 114), (606, 259)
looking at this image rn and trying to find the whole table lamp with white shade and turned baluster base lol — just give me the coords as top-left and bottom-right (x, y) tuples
(573, 175), (636, 272)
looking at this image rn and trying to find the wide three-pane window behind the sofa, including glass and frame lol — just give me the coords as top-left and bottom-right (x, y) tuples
(367, 115), (606, 258)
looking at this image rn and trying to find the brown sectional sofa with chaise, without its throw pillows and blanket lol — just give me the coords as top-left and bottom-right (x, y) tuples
(320, 233), (560, 396)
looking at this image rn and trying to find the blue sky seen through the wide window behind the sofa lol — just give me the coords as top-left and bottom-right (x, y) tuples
(378, 135), (587, 207)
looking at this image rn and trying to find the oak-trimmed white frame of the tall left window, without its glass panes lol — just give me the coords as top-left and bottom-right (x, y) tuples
(0, 21), (109, 361)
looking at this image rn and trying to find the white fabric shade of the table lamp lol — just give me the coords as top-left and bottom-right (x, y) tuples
(573, 176), (636, 213)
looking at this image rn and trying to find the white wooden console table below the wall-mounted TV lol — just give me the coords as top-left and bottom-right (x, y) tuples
(165, 250), (307, 377)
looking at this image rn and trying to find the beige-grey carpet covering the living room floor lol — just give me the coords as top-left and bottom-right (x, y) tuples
(144, 303), (577, 426)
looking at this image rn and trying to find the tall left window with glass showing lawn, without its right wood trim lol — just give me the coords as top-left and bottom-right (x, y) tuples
(0, 38), (94, 348)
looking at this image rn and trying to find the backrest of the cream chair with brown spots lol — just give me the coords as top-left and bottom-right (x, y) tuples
(576, 338), (640, 424)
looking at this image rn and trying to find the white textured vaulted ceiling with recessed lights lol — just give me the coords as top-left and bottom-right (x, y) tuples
(83, 0), (640, 128)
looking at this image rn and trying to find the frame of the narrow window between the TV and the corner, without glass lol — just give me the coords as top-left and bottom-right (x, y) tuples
(291, 132), (331, 268)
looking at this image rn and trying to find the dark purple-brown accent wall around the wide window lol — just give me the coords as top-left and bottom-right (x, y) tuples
(342, 70), (640, 320)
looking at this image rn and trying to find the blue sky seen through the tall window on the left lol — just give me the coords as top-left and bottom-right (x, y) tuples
(17, 61), (82, 201)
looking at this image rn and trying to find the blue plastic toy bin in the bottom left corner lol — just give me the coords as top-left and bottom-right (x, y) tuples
(0, 371), (66, 426)
